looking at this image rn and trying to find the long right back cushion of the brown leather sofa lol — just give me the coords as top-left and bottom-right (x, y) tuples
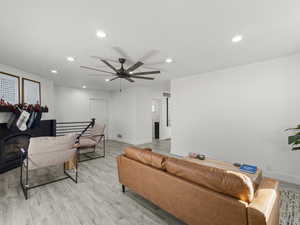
(165, 158), (254, 203)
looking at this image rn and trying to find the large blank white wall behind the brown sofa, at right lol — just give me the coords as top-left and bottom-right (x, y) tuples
(171, 55), (300, 184)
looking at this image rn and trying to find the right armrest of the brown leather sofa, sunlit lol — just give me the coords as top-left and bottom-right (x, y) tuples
(248, 178), (280, 225)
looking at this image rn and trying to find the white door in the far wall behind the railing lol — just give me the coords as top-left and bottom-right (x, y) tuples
(90, 98), (108, 136)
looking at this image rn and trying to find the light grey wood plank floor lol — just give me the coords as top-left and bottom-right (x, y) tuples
(0, 141), (300, 225)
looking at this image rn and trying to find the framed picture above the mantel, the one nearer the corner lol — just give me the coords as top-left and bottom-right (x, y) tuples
(22, 78), (42, 105)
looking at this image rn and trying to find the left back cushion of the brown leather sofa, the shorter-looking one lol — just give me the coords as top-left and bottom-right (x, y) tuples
(124, 147), (167, 170)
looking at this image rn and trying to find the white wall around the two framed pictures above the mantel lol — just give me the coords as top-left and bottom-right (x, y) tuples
(0, 64), (55, 123)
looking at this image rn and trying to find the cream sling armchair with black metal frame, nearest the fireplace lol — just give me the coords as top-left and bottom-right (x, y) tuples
(20, 134), (78, 199)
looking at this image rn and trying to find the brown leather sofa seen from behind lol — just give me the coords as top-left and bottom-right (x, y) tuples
(117, 147), (279, 225)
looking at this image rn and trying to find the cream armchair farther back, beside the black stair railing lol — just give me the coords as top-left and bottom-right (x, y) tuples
(79, 123), (106, 162)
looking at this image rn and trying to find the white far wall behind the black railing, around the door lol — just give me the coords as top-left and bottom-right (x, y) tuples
(54, 86), (110, 122)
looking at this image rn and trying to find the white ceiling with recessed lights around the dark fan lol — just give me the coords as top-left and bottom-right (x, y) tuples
(0, 0), (300, 90)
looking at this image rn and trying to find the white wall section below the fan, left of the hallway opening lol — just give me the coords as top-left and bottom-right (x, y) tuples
(110, 85), (170, 144)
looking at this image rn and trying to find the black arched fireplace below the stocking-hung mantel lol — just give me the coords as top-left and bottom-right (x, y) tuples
(0, 134), (31, 173)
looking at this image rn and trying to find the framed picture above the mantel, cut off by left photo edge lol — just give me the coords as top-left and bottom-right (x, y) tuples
(0, 71), (20, 105)
